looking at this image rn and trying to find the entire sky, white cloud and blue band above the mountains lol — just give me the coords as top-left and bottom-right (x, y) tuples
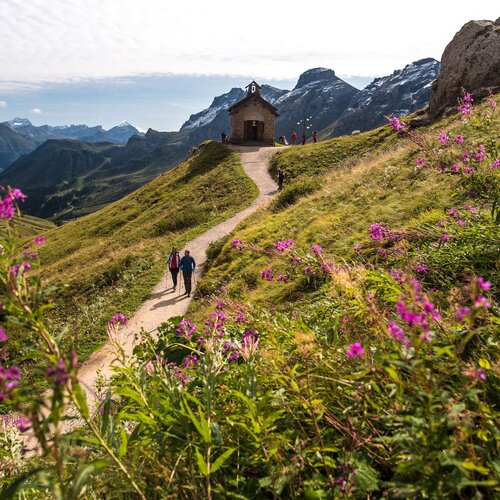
(0, 0), (500, 130)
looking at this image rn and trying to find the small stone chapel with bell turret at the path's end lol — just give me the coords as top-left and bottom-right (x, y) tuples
(228, 81), (279, 146)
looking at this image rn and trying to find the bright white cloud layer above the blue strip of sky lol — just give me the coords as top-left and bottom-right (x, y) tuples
(0, 0), (498, 88)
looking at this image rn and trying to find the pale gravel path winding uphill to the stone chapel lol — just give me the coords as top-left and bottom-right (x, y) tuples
(79, 146), (277, 408)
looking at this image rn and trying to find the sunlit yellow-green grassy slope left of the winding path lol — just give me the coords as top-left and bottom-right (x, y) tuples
(32, 142), (257, 357)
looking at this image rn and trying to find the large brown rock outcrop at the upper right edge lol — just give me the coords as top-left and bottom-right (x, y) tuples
(429, 18), (500, 117)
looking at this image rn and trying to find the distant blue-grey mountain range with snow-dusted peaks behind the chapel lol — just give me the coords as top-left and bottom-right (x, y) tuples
(0, 59), (439, 221)
